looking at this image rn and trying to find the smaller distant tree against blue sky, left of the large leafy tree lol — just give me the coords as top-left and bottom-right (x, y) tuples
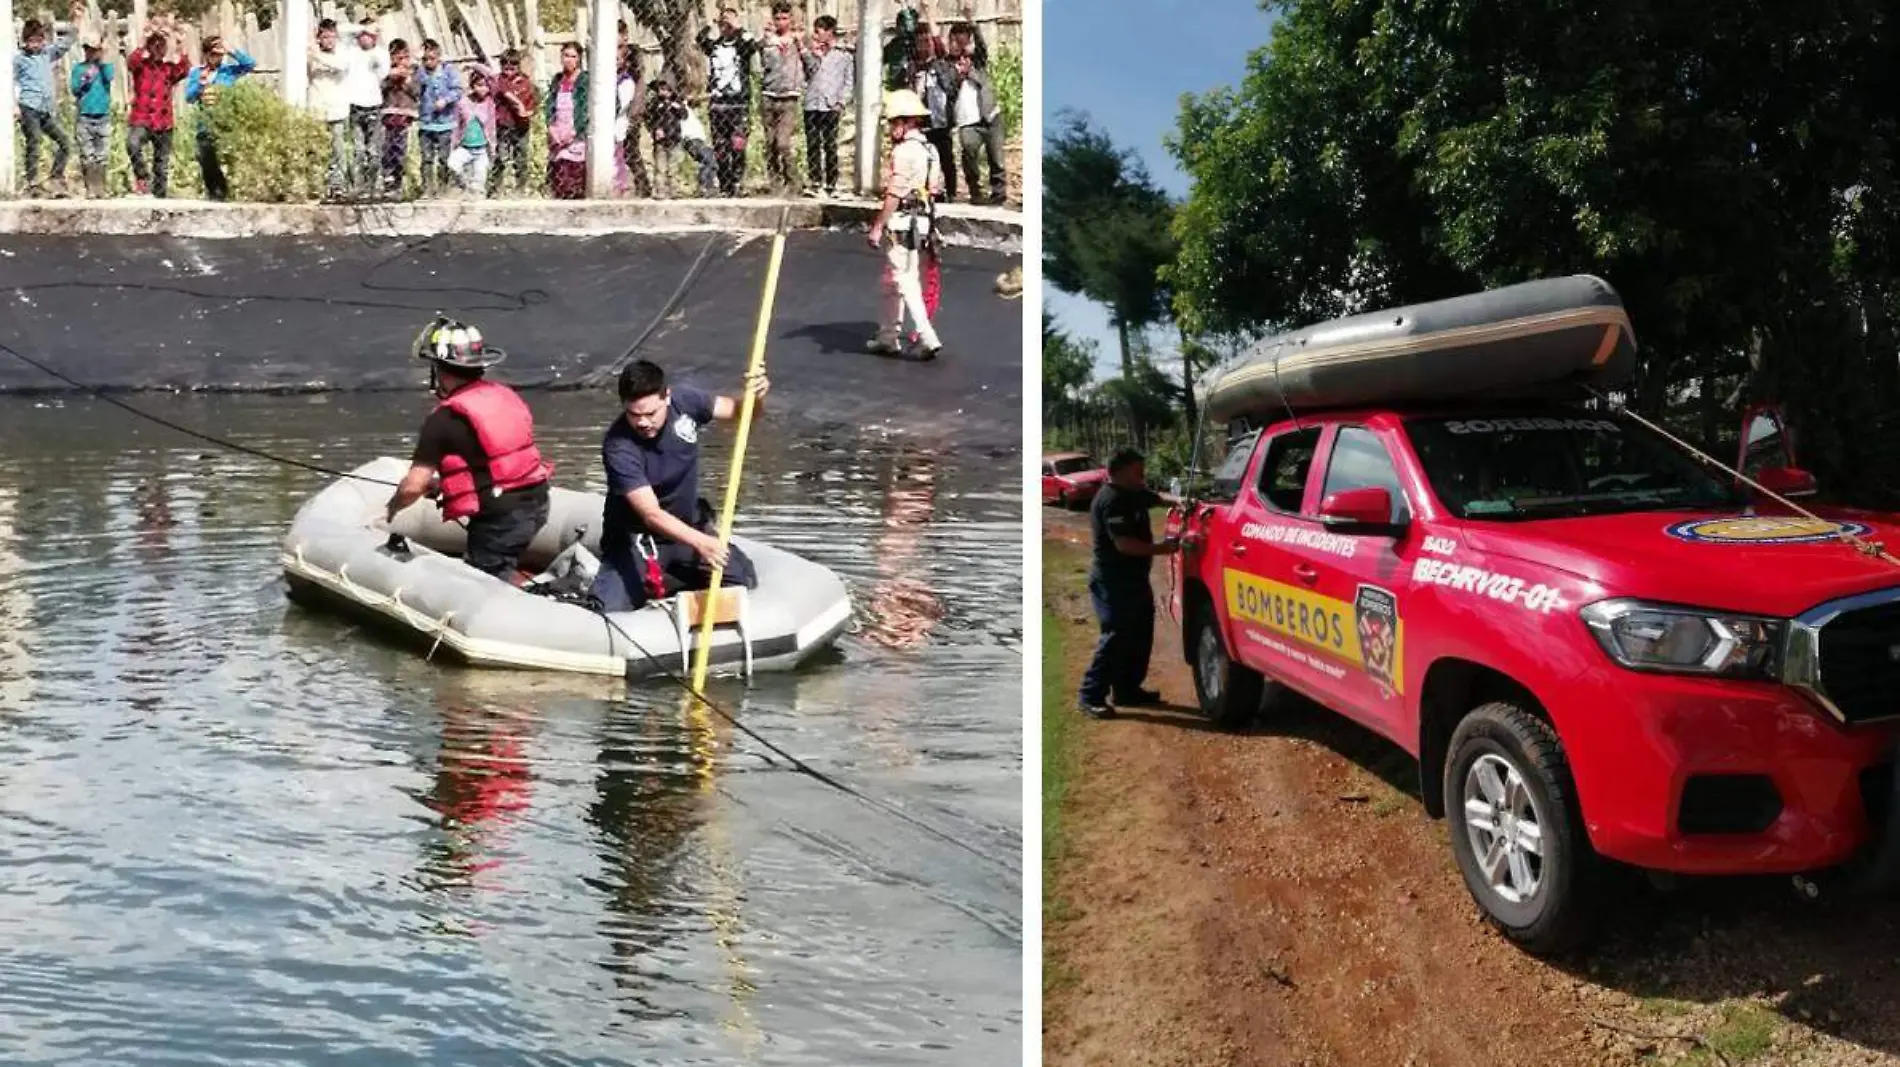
(1043, 110), (1174, 389)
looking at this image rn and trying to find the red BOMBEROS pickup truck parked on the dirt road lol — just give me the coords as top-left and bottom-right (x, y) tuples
(1169, 402), (1900, 953)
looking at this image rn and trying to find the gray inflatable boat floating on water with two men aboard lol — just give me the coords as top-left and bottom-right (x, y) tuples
(281, 456), (851, 678)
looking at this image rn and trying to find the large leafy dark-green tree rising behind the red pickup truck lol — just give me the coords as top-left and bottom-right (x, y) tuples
(1167, 0), (1900, 497)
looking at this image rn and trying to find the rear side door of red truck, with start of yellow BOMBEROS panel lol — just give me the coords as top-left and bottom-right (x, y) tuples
(1222, 425), (1351, 704)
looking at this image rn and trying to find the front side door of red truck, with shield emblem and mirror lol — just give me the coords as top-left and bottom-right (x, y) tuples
(1311, 425), (1412, 737)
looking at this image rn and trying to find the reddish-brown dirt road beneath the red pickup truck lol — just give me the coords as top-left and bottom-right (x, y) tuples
(1043, 509), (1900, 1067)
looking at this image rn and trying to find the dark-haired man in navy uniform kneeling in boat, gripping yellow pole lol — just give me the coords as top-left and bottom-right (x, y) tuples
(593, 359), (770, 611)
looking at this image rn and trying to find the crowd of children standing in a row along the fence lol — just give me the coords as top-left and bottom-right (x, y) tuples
(13, 0), (1003, 199)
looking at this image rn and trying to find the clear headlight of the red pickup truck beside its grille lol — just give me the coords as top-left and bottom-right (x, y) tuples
(1583, 600), (1786, 678)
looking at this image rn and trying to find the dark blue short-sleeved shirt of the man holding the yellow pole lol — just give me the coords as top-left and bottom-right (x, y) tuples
(600, 385), (713, 554)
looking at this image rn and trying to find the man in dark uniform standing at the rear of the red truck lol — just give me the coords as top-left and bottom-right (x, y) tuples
(1077, 448), (1180, 720)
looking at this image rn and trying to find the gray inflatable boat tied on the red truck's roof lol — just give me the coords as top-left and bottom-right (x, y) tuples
(1207, 273), (1636, 421)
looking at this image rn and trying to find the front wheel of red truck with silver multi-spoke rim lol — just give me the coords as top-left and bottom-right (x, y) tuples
(1444, 702), (1600, 955)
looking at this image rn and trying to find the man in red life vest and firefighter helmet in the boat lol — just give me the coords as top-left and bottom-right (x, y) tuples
(386, 317), (555, 581)
